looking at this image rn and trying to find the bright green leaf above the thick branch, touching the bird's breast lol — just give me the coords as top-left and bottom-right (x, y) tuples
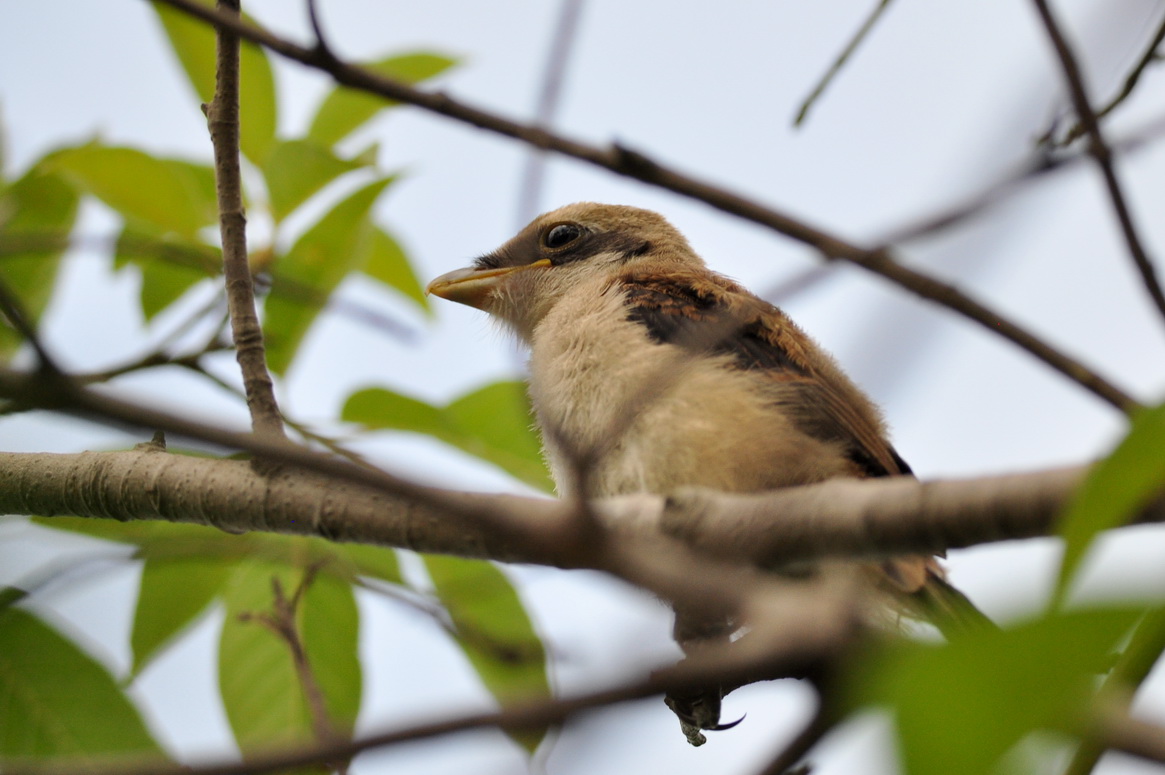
(340, 381), (553, 492)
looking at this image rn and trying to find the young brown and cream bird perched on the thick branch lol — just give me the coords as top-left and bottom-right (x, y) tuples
(429, 203), (982, 745)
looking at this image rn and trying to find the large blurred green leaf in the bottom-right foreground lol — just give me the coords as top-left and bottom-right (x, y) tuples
(850, 610), (1141, 775)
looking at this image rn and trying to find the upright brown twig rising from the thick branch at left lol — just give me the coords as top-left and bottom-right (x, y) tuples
(206, 0), (283, 438)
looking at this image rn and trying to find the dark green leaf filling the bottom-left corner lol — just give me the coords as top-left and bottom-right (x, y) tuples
(0, 607), (163, 763)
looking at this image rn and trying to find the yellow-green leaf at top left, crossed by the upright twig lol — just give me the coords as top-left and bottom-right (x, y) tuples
(150, 0), (278, 164)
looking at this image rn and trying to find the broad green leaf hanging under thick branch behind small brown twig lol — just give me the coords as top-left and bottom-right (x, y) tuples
(219, 552), (360, 754)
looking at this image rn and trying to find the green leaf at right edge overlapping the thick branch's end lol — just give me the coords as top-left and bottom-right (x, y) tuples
(1057, 404), (1165, 599)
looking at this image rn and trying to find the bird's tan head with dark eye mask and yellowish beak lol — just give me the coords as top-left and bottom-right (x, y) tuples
(426, 202), (704, 336)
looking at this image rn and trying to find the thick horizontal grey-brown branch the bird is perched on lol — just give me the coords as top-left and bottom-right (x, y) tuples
(0, 451), (1165, 566)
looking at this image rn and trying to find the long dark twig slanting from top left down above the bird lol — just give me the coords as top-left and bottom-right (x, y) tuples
(143, 0), (1139, 413)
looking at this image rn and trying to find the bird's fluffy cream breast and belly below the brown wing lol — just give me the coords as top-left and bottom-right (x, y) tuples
(530, 284), (849, 495)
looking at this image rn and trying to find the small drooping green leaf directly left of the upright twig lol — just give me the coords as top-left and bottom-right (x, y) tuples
(114, 219), (223, 320)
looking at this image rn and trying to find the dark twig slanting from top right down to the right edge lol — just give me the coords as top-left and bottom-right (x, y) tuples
(1032, 0), (1165, 322)
